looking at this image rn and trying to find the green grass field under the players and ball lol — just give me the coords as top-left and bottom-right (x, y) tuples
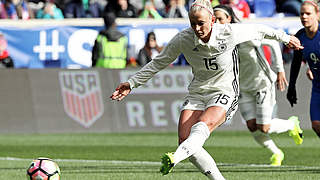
(0, 130), (320, 180)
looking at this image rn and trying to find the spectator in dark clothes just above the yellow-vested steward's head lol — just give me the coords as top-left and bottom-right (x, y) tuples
(104, 0), (138, 18)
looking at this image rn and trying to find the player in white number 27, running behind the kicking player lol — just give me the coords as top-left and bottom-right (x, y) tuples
(213, 5), (303, 166)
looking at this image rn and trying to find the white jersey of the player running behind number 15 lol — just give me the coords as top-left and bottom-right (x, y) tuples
(238, 39), (284, 91)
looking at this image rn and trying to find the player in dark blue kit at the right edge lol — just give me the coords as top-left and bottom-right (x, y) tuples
(287, 1), (320, 137)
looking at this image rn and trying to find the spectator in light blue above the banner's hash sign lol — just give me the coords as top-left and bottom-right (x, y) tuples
(36, 2), (64, 19)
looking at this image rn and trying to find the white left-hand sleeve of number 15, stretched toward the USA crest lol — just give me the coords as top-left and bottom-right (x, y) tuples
(128, 33), (182, 89)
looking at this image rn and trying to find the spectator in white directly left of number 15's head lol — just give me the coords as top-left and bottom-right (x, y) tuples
(167, 0), (188, 18)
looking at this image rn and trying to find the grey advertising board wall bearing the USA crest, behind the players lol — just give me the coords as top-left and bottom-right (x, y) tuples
(0, 65), (311, 133)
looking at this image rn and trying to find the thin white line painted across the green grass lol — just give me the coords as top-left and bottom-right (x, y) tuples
(0, 157), (320, 169)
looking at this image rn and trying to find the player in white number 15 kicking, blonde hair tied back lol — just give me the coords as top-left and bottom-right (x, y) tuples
(111, 0), (302, 180)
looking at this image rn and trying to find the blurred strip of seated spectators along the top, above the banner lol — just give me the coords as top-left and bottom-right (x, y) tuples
(0, 0), (308, 19)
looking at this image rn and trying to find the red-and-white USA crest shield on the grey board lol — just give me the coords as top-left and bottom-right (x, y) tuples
(59, 71), (104, 128)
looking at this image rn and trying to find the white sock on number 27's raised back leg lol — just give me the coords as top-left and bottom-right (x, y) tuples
(268, 118), (294, 134)
